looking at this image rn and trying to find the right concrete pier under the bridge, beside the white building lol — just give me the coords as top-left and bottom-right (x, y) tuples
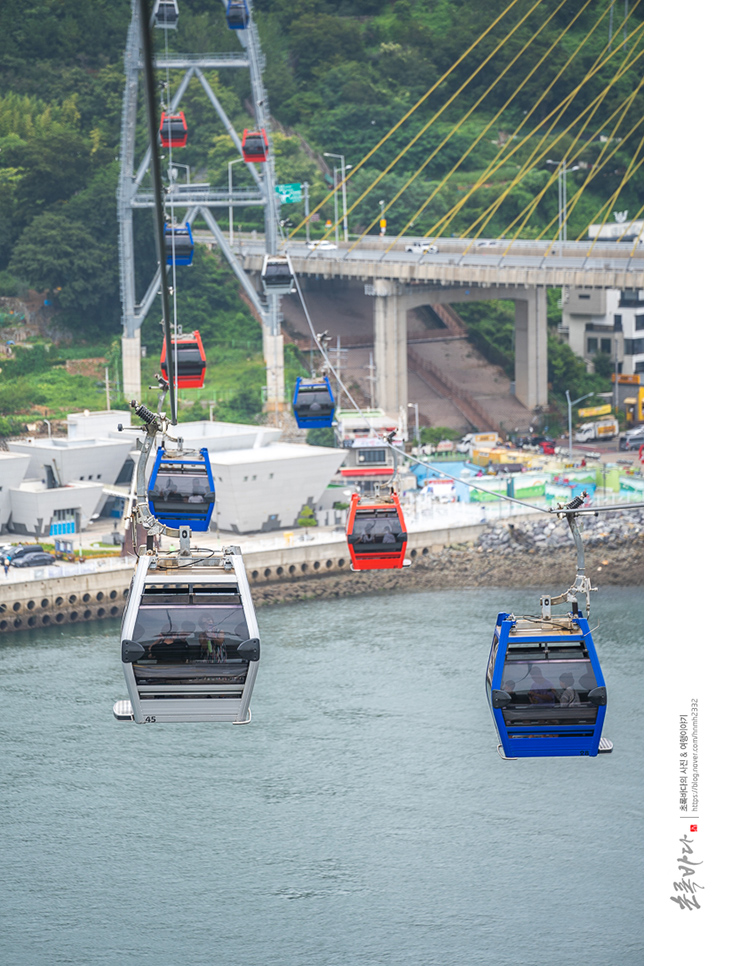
(514, 285), (548, 409)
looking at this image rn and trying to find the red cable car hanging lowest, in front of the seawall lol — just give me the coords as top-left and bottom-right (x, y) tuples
(347, 489), (411, 570)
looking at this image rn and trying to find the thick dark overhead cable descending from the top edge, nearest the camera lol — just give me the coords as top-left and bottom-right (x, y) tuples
(137, 0), (177, 426)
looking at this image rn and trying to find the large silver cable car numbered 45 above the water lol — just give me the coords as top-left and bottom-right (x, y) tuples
(114, 547), (260, 724)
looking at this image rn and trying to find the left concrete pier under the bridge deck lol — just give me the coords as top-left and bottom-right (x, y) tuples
(373, 279), (408, 416)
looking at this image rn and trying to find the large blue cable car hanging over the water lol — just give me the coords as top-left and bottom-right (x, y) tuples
(486, 607), (613, 758)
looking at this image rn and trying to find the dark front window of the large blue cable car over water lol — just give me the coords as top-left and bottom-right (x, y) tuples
(501, 645), (598, 725)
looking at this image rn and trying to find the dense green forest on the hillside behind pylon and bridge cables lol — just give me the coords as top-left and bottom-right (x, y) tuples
(0, 0), (643, 428)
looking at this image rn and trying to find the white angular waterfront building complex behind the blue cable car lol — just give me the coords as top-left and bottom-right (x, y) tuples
(0, 411), (346, 538)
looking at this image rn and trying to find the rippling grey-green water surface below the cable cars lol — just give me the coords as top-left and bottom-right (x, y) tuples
(0, 588), (643, 966)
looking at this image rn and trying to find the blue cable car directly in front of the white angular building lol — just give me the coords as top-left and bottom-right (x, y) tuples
(147, 446), (215, 532)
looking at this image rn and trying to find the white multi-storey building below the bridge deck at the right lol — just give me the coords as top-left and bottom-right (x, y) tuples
(558, 286), (644, 381)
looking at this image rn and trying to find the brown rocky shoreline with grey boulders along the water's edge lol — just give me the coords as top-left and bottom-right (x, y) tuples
(251, 510), (644, 606)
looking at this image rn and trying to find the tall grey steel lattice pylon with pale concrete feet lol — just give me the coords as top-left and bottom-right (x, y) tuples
(117, 0), (285, 410)
